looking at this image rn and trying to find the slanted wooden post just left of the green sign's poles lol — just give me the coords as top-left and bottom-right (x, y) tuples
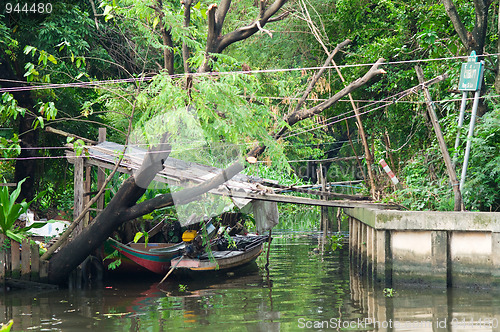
(415, 66), (462, 211)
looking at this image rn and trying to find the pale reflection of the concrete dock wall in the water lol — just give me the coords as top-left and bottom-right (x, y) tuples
(350, 254), (500, 331)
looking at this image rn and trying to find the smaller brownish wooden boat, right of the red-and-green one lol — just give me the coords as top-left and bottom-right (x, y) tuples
(171, 236), (267, 274)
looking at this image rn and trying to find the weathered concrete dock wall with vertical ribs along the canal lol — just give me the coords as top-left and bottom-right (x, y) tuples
(344, 208), (500, 288)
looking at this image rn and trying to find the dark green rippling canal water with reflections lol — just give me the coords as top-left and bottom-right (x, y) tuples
(0, 232), (500, 331)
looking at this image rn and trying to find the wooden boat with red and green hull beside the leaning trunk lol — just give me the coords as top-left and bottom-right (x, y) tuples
(104, 223), (215, 275)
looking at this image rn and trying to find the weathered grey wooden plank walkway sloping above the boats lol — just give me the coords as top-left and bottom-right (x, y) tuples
(66, 141), (386, 209)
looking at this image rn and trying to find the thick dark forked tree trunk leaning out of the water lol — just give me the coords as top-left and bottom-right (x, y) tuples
(48, 136), (243, 284)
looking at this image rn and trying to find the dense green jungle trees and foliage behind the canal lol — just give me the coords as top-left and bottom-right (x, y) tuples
(0, 0), (500, 222)
